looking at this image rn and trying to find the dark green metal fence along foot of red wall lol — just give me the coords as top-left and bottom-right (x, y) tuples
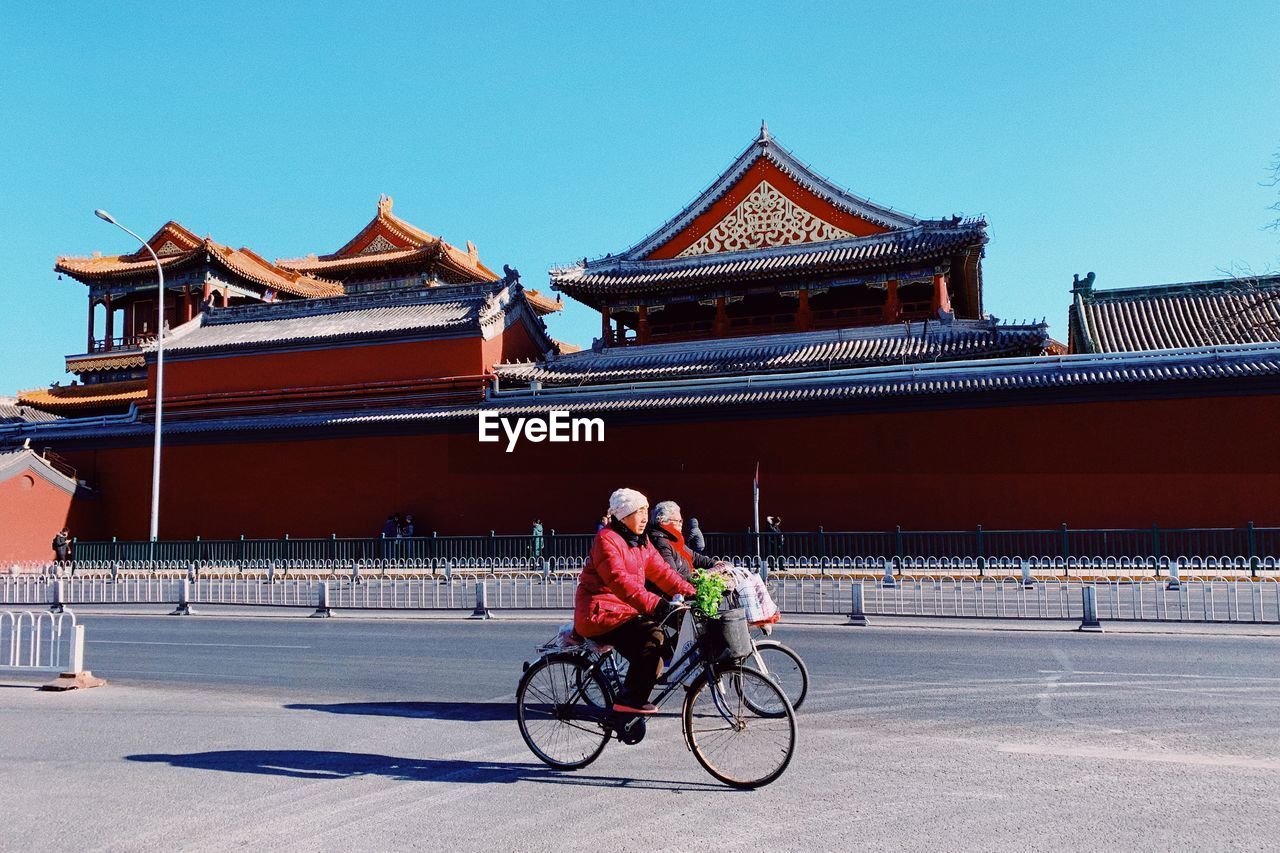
(62, 523), (1280, 565)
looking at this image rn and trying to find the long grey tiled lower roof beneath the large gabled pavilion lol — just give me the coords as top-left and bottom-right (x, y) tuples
(495, 320), (1051, 386)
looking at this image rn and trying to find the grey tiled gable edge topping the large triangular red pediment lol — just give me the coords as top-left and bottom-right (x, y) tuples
(620, 122), (920, 260)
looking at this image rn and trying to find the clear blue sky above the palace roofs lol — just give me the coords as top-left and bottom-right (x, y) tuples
(0, 0), (1280, 394)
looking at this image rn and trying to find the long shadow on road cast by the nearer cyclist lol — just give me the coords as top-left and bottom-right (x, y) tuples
(125, 749), (732, 793)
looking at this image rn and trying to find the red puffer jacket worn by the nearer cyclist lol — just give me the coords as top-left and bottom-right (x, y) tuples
(573, 528), (695, 637)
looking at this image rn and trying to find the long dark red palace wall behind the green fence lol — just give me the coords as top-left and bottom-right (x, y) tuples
(41, 396), (1280, 544)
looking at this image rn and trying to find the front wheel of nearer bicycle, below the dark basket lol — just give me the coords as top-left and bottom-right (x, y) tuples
(684, 666), (796, 788)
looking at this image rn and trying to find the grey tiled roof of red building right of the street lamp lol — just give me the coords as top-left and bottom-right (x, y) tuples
(160, 282), (554, 357)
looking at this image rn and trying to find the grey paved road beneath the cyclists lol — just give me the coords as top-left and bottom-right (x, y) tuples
(0, 616), (1280, 850)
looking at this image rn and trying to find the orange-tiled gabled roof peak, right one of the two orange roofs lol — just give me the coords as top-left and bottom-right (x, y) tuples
(275, 196), (498, 283)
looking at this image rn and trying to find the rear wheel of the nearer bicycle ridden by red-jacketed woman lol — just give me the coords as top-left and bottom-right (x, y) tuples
(516, 654), (613, 770)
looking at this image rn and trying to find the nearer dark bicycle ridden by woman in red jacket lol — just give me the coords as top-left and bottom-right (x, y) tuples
(516, 605), (796, 789)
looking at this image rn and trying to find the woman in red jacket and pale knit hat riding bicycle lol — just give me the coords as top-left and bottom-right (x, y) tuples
(573, 489), (695, 713)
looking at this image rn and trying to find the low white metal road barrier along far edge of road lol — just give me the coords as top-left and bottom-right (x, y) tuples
(0, 573), (1280, 624)
